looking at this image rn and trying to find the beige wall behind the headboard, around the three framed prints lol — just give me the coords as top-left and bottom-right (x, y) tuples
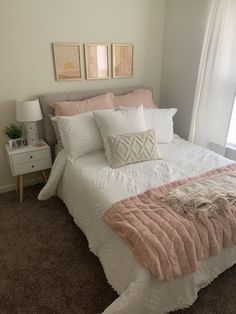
(0, 0), (165, 189)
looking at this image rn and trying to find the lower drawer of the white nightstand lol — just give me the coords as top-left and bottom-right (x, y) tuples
(13, 158), (52, 176)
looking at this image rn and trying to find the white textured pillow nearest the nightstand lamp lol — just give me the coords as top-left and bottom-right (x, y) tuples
(55, 110), (107, 160)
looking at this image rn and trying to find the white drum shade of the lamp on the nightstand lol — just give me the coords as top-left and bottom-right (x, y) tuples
(16, 99), (43, 122)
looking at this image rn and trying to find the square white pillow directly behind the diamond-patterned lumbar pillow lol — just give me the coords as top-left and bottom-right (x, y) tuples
(93, 106), (146, 160)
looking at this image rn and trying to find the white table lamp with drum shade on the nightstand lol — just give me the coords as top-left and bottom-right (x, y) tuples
(16, 99), (43, 145)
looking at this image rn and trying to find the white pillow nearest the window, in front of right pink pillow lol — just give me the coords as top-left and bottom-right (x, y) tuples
(119, 106), (177, 144)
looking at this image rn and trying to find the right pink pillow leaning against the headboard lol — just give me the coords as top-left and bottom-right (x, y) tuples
(114, 89), (156, 108)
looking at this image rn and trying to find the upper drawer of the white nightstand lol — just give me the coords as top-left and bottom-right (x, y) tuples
(11, 149), (50, 165)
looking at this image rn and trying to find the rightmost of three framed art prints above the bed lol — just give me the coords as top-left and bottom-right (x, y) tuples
(112, 44), (134, 78)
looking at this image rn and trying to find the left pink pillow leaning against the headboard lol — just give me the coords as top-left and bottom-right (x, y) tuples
(50, 93), (114, 116)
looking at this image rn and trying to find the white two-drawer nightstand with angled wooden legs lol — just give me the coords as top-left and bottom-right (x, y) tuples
(5, 140), (52, 203)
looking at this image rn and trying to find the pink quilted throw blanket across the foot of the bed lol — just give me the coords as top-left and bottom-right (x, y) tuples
(104, 164), (236, 280)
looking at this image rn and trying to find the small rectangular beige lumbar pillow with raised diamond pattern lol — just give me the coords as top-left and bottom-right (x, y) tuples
(107, 130), (158, 168)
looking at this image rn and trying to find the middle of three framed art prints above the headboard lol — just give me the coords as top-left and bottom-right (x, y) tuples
(84, 44), (111, 80)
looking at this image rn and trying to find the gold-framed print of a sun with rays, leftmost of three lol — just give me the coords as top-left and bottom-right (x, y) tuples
(52, 43), (83, 81)
